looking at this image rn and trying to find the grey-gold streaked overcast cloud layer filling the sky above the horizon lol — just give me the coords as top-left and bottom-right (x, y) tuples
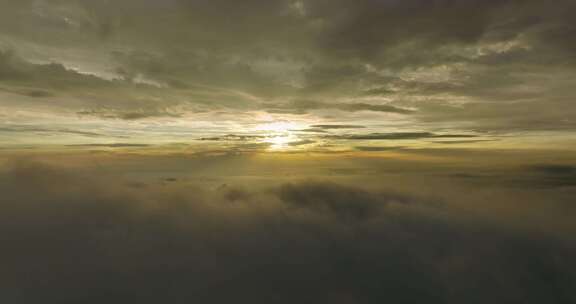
(0, 0), (576, 150)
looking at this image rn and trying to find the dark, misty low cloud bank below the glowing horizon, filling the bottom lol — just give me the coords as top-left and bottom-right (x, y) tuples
(0, 162), (576, 303)
